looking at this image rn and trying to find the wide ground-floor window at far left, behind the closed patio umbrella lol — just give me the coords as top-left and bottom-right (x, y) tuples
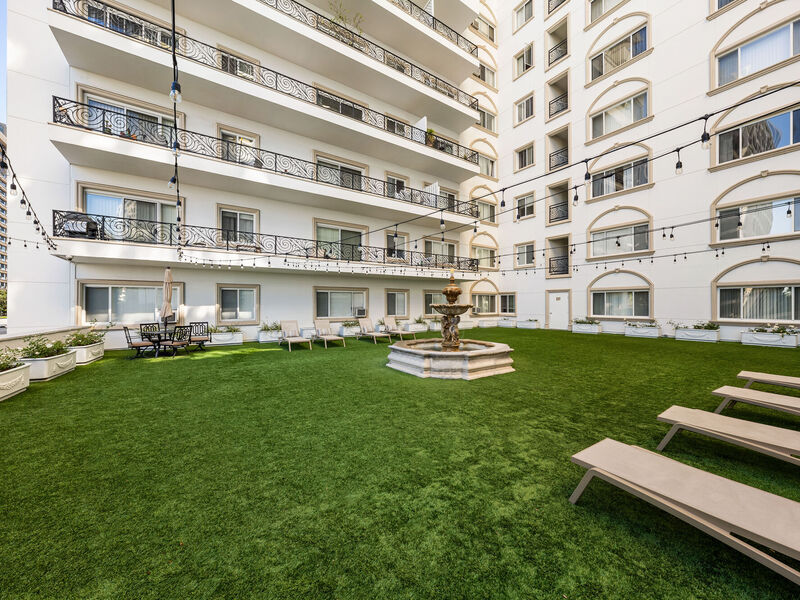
(83, 285), (181, 324)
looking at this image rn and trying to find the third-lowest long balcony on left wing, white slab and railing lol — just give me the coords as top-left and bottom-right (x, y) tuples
(51, 0), (478, 181)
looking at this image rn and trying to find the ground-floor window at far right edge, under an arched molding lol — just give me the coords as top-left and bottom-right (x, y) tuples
(719, 285), (800, 322)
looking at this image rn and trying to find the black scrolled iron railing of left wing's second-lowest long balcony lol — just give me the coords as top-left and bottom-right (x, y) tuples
(53, 96), (478, 217)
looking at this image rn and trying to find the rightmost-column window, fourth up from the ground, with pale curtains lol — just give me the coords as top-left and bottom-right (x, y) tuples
(717, 20), (800, 85)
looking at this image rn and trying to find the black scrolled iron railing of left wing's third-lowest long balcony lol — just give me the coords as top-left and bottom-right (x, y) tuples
(53, 0), (478, 164)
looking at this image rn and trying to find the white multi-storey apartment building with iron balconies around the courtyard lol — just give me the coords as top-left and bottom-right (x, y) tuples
(8, 0), (800, 345)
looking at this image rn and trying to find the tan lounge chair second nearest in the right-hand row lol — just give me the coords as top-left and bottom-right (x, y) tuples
(657, 406), (800, 466)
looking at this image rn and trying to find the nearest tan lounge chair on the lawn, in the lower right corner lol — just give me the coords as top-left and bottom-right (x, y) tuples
(569, 439), (800, 585)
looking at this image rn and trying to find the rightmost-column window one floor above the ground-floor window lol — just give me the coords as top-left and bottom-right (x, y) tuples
(715, 198), (800, 240)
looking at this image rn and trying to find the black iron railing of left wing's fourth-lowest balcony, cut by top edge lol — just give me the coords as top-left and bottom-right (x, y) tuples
(252, 0), (478, 109)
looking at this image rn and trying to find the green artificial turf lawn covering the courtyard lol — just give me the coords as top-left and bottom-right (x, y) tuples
(0, 329), (800, 600)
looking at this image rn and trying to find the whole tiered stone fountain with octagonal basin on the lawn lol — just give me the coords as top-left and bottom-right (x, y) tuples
(387, 270), (514, 379)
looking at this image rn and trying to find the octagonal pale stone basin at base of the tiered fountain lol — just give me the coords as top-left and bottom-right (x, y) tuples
(386, 340), (514, 379)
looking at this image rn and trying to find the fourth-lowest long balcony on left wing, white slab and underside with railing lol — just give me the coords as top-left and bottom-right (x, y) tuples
(134, 0), (478, 131)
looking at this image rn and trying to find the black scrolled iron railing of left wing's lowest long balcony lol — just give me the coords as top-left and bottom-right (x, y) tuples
(53, 210), (478, 272)
